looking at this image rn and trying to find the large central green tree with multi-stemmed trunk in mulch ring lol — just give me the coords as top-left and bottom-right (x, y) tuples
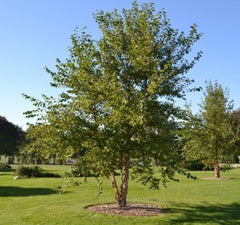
(25, 1), (201, 207)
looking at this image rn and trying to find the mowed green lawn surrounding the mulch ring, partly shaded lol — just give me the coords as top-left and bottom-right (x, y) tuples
(0, 166), (240, 225)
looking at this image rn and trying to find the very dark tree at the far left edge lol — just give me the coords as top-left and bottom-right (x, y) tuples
(0, 116), (25, 163)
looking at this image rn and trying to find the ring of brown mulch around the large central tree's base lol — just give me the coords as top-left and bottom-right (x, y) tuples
(86, 203), (163, 216)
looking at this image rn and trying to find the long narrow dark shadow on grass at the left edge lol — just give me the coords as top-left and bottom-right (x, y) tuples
(0, 186), (57, 197)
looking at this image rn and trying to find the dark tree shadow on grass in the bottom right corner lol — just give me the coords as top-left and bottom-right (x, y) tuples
(167, 203), (240, 225)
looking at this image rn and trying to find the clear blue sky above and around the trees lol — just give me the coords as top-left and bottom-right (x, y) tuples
(0, 0), (240, 130)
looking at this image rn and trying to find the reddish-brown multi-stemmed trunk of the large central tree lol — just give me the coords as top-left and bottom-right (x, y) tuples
(111, 156), (130, 208)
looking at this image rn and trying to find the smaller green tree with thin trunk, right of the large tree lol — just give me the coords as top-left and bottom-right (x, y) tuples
(181, 82), (239, 178)
